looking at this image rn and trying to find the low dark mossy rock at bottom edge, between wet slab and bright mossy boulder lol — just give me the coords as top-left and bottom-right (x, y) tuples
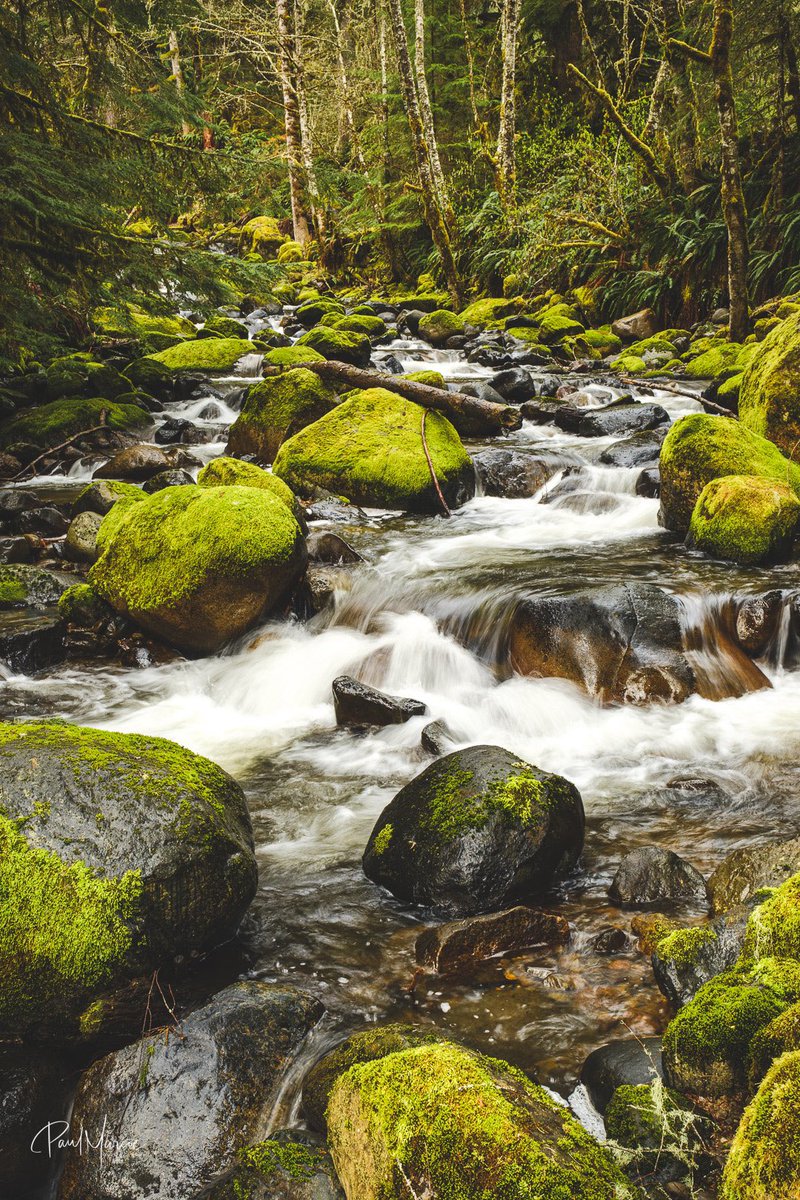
(201, 1129), (344, 1200)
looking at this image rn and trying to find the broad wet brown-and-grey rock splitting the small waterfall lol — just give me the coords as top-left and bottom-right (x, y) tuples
(509, 583), (696, 704)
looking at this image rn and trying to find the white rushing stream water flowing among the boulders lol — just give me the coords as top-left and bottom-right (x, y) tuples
(6, 324), (800, 1123)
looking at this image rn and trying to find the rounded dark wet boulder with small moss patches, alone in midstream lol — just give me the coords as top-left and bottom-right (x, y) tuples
(363, 746), (584, 917)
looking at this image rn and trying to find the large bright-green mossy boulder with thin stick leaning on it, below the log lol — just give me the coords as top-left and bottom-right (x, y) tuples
(273, 388), (475, 512)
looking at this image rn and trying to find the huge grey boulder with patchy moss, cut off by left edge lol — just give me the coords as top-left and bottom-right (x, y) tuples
(0, 721), (257, 1037)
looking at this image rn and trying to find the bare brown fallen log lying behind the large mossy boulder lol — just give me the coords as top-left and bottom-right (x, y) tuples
(265, 361), (522, 436)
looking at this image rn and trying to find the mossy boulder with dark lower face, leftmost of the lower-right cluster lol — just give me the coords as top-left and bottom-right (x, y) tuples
(663, 958), (800, 1099)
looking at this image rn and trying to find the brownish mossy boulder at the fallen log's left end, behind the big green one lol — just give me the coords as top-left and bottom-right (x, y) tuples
(228, 367), (335, 462)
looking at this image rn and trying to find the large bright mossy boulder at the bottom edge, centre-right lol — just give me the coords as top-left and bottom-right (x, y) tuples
(327, 1043), (639, 1200)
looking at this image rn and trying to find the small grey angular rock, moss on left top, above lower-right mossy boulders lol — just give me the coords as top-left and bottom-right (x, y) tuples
(652, 905), (750, 1004)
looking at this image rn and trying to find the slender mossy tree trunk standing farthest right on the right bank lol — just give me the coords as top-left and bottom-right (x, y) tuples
(710, 0), (750, 342)
